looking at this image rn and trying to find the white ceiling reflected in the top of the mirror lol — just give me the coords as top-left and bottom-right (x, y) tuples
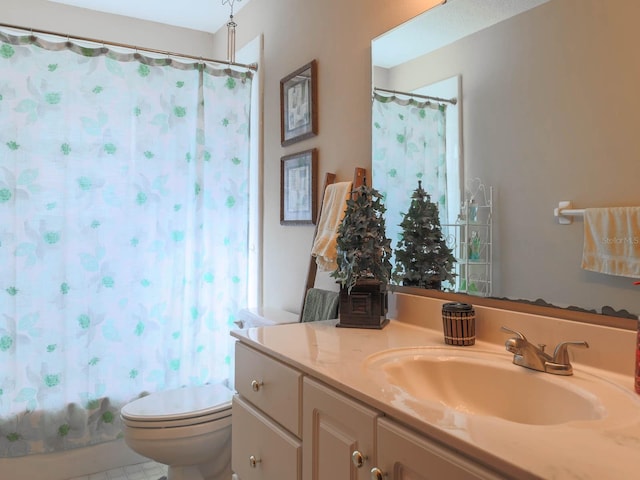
(372, 0), (549, 68)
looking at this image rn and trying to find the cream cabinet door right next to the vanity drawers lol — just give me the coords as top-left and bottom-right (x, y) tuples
(304, 377), (378, 480)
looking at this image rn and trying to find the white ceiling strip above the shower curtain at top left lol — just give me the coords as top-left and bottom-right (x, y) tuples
(49, 0), (250, 33)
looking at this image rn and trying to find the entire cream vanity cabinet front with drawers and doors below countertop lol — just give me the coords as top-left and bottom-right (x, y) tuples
(232, 342), (508, 480)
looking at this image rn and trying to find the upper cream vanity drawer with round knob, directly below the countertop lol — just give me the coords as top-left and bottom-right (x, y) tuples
(235, 342), (302, 437)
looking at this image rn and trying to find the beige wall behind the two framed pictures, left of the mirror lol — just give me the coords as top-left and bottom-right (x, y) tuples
(216, 0), (437, 312)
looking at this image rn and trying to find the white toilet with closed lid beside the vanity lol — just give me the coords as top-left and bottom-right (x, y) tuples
(120, 384), (233, 480)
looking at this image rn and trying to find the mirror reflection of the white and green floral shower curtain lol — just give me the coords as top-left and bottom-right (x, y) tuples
(372, 93), (448, 268)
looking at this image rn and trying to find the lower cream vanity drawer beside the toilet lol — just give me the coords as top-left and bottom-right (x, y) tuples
(231, 395), (302, 480)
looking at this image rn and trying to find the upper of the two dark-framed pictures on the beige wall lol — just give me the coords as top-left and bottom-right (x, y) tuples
(280, 60), (318, 146)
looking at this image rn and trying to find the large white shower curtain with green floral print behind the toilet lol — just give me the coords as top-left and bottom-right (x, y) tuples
(0, 31), (252, 457)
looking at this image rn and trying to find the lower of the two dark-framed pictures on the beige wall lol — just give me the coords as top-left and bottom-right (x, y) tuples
(280, 148), (318, 225)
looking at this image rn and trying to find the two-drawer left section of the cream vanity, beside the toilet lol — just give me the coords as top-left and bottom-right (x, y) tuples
(231, 342), (302, 480)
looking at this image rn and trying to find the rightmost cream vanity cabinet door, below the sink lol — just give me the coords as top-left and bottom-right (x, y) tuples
(371, 418), (500, 480)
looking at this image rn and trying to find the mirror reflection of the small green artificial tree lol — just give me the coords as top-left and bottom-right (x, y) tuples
(393, 181), (456, 289)
